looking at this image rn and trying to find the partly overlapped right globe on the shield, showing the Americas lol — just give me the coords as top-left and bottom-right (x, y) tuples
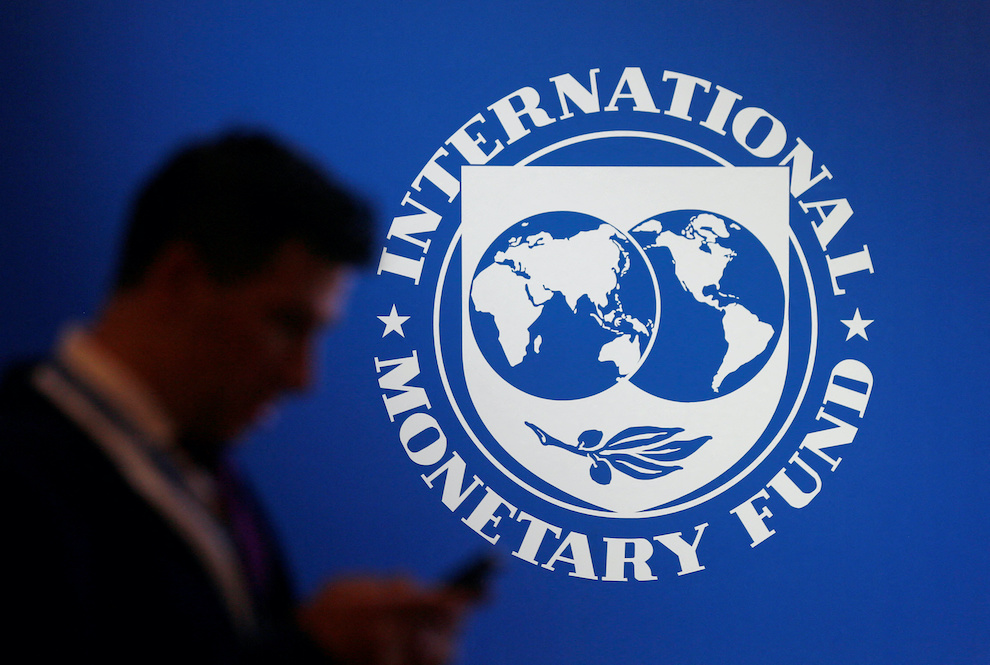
(629, 210), (784, 402)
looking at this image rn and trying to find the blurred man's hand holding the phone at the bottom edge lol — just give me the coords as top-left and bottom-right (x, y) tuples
(299, 577), (472, 665)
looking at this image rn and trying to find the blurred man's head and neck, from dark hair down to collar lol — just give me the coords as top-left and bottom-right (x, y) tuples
(96, 134), (371, 452)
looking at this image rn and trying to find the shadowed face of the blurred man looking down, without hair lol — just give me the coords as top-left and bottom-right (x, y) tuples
(179, 241), (348, 441)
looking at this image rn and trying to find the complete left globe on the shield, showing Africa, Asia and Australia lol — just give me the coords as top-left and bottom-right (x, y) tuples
(469, 211), (660, 400)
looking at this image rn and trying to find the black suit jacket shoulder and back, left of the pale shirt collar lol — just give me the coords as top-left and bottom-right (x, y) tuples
(0, 363), (260, 662)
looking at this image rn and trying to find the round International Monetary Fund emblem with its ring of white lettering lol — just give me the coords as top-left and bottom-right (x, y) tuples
(375, 67), (873, 581)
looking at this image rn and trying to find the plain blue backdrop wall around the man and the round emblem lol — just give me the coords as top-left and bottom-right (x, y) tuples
(0, 0), (990, 664)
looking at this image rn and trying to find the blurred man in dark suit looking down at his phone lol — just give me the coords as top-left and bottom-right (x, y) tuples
(0, 134), (463, 664)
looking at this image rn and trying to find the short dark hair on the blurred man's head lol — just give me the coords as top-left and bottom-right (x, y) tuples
(114, 132), (372, 289)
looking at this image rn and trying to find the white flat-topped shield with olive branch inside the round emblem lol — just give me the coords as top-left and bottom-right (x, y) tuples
(450, 166), (790, 517)
